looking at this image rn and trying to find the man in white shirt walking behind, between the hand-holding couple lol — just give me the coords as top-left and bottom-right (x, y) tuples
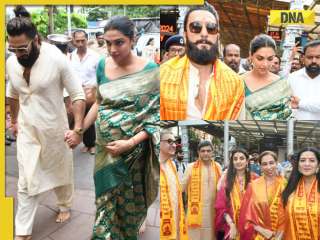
(71, 30), (100, 154)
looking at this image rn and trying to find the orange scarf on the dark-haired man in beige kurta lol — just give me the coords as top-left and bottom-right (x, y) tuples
(187, 160), (221, 228)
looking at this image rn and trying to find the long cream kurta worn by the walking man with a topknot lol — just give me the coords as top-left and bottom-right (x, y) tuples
(6, 42), (85, 196)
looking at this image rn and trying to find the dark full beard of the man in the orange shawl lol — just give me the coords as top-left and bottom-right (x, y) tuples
(186, 38), (219, 65)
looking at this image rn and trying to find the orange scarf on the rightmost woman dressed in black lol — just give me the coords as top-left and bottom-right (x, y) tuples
(288, 178), (320, 240)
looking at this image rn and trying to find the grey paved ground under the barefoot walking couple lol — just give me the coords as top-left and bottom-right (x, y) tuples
(6, 143), (160, 240)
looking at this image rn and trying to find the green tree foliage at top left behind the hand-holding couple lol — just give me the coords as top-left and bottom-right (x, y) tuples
(31, 8), (87, 37)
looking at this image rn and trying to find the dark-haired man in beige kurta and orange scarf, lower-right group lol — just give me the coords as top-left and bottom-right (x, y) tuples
(182, 141), (221, 240)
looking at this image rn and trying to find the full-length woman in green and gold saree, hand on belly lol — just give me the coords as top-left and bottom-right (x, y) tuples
(84, 16), (160, 240)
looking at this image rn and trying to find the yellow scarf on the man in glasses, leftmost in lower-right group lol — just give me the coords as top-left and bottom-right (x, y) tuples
(160, 159), (188, 240)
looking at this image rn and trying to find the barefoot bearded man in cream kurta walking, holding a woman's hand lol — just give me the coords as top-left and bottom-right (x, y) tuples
(6, 15), (85, 239)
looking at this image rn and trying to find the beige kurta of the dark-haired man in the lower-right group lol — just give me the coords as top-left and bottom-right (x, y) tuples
(182, 160), (217, 240)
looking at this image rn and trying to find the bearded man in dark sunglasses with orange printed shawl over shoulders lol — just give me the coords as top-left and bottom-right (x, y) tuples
(160, 4), (244, 120)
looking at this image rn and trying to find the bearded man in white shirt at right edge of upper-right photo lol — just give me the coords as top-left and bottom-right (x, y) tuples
(289, 40), (320, 120)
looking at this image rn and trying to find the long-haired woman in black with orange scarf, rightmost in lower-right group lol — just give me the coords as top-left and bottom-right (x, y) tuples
(282, 147), (320, 240)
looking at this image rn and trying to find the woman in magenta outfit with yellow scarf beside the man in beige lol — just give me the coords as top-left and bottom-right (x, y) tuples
(215, 148), (258, 240)
